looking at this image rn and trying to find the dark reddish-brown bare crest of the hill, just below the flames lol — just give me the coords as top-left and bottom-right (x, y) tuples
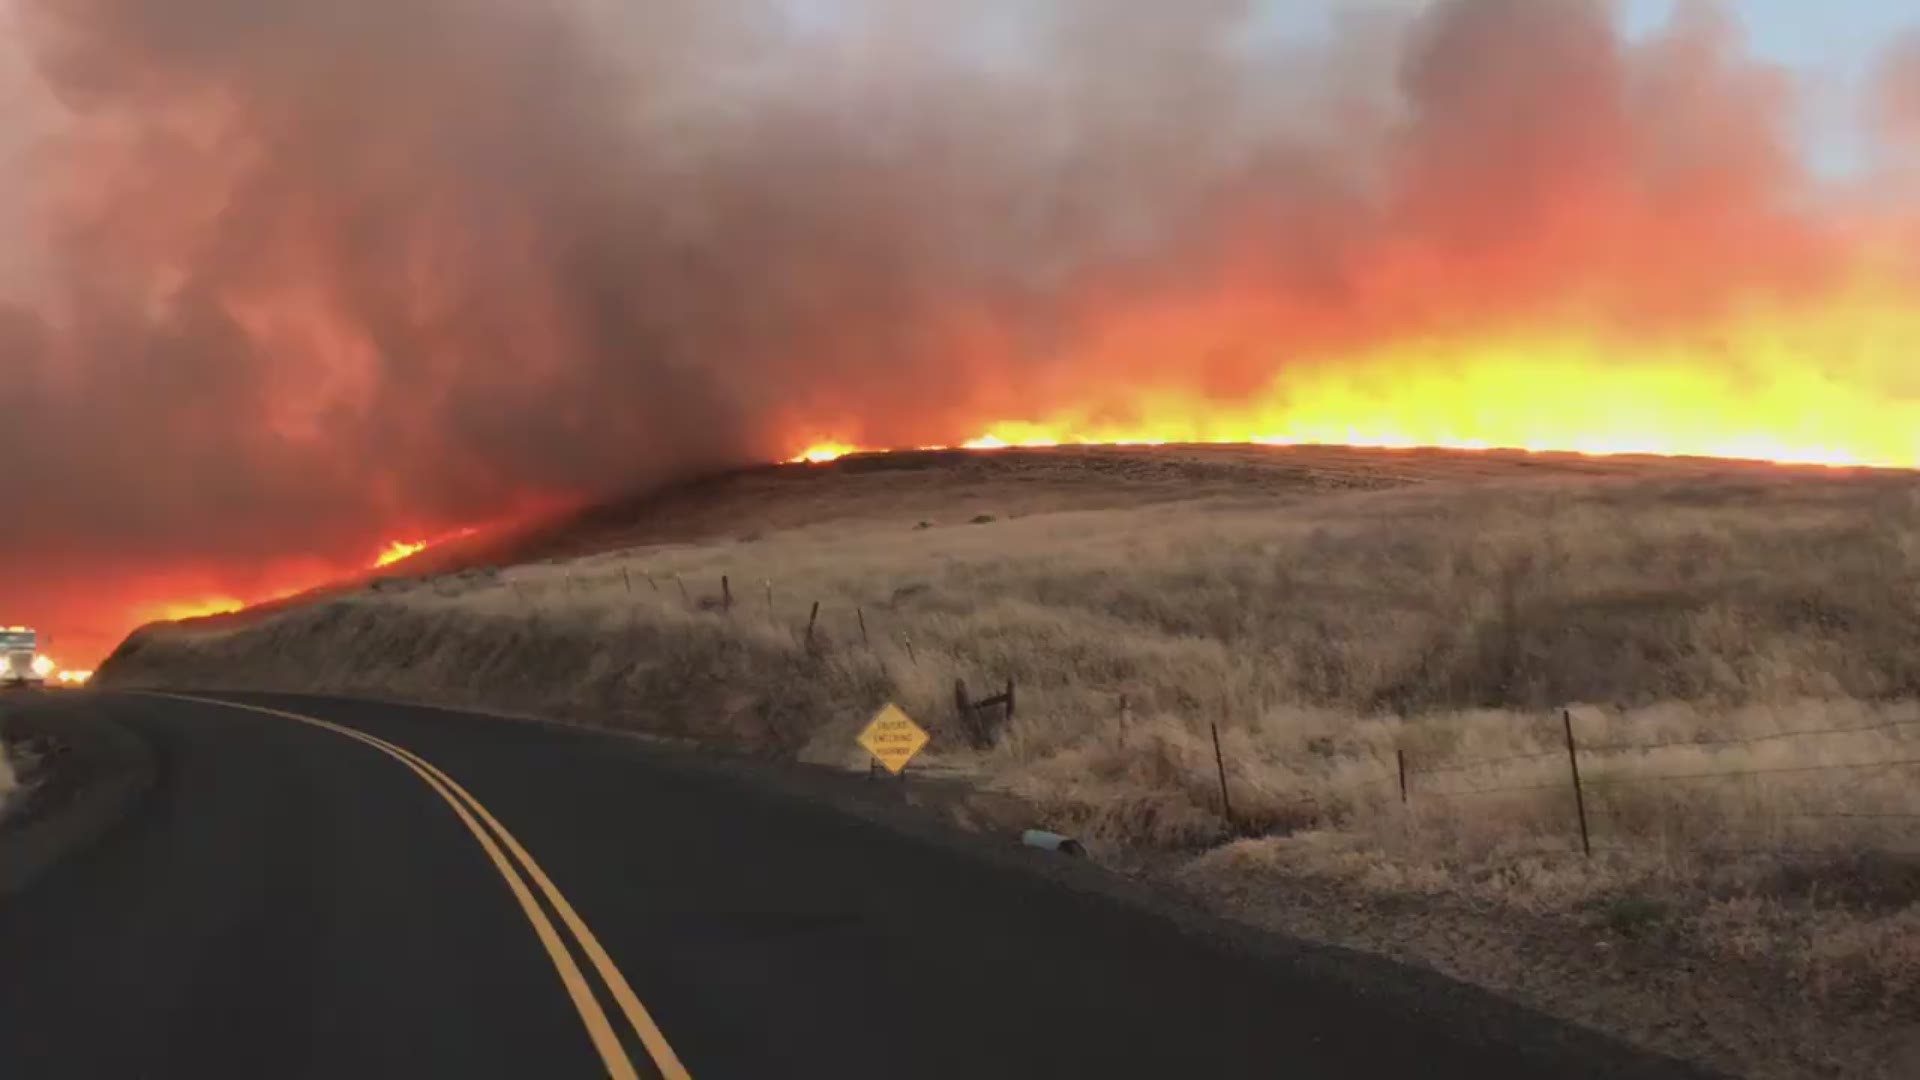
(432, 446), (1843, 573)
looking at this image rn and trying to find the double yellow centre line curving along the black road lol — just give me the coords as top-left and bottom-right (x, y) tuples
(154, 694), (689, 1080)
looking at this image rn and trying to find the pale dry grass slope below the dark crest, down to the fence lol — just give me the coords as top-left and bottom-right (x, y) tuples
(109, 447), (1920, 847)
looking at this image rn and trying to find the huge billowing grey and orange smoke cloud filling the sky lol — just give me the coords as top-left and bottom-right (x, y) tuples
(0, 0), (1920, 661)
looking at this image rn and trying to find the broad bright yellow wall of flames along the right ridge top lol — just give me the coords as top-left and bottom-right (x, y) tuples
(779, 274), (1920, 469)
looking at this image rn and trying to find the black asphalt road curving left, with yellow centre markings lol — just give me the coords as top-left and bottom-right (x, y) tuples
(0, 694), (1712, 1080)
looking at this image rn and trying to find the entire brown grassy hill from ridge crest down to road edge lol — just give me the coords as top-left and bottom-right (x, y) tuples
(102, 448), (1920, 1076)
